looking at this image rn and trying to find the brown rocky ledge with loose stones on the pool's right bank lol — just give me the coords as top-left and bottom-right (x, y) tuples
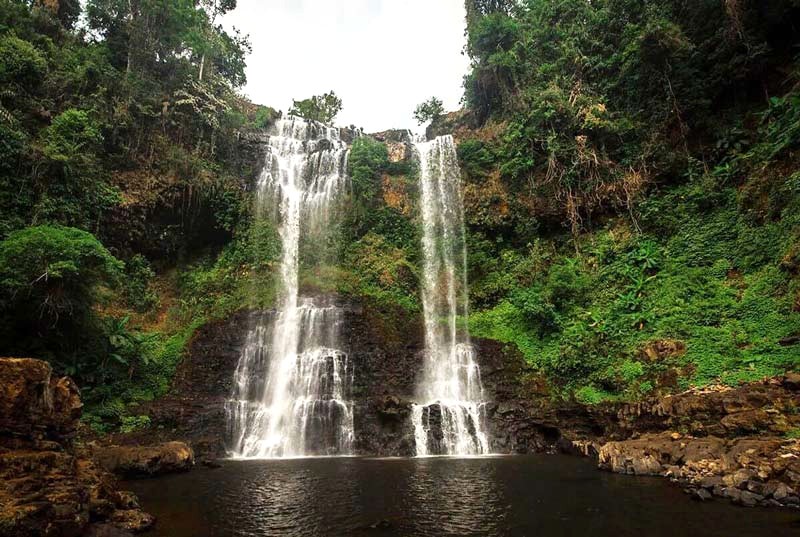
(573, 374), (800, 507)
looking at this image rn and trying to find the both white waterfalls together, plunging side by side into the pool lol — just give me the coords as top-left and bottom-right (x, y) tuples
(226, 118), (489, 459)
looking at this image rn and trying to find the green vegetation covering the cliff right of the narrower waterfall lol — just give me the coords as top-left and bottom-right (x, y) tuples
(459, 0), (800, 403)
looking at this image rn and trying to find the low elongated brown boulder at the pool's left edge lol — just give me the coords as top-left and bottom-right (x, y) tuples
(92, 442), (194, 478)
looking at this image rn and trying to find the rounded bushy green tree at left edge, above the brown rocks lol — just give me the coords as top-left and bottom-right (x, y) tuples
(0, 226), (128, 384)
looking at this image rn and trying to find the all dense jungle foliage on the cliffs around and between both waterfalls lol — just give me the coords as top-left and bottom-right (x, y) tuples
(0, 0), (800, 430)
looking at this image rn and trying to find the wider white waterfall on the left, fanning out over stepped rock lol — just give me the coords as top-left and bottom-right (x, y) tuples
(226, 118), (354, 458)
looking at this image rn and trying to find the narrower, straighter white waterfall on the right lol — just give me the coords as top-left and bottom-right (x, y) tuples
(412, 136), (489, 456)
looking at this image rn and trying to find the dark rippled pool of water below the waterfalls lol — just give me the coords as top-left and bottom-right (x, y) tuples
(126, 455), (800, 537)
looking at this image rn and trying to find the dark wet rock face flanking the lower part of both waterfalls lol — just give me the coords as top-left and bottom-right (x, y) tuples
(126, 303), (560, 456)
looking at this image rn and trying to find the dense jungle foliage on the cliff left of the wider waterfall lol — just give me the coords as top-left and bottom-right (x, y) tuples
(0, 0), (279, 425)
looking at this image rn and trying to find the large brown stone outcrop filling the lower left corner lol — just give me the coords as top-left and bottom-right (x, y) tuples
(0, 358), (154, 537)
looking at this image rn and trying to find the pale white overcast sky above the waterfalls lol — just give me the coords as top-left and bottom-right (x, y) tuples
(223, 0), (469, 132)
